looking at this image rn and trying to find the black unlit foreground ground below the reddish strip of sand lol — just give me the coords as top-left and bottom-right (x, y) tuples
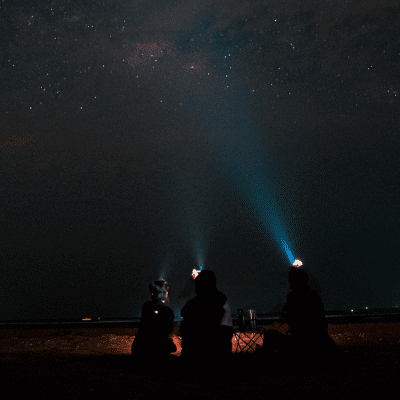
(0, 343), (400, 399)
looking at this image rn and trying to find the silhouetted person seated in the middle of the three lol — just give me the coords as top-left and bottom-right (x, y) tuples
(181, 270), (233, 361)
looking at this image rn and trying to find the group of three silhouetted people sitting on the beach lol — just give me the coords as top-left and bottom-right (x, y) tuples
(132, 267), (337, 368)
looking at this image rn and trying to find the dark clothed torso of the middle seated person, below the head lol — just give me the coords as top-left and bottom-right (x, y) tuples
(181, 290), (227, 357)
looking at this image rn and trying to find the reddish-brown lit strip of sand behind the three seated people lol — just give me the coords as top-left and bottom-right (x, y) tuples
(0, 323), (400, 357)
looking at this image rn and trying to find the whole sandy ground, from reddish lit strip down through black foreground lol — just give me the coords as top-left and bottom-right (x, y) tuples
(0, 323), (400, 399)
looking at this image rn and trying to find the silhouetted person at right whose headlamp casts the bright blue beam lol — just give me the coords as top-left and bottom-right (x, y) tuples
(264, 267), (336, 361)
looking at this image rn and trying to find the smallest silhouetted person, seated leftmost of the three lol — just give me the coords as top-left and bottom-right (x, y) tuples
(132, 279), (176, 363)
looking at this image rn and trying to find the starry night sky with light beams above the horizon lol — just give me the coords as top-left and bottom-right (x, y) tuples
(0, 0), (400, 320)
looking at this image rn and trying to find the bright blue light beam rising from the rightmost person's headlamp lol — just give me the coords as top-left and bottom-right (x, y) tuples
(151, 35), (295, 264)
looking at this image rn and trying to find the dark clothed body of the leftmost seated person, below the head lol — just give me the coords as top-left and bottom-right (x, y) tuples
(132, 301), (176, 356)
